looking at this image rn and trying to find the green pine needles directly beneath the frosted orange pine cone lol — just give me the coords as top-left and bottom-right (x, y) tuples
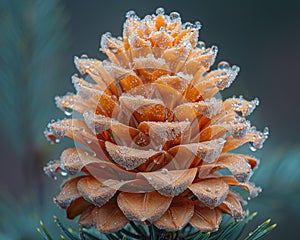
(38, 211), (276, 240)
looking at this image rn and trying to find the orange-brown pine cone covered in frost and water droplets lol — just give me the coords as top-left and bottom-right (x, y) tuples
(45, 9), (268, 232)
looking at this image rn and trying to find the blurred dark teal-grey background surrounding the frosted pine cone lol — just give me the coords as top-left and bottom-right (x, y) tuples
(0, 0), (300, 240)
